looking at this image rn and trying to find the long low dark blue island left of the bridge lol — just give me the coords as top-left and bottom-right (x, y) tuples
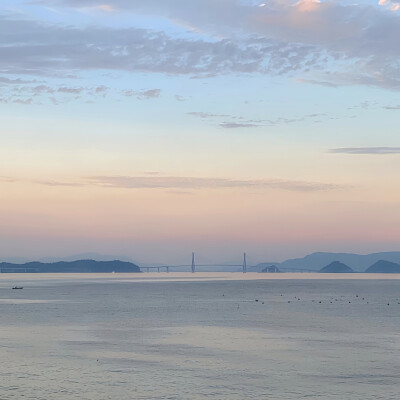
(0, 260), (141, 274)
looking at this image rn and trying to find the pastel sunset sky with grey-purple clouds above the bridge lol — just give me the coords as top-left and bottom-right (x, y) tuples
(0, 0), (400, 264)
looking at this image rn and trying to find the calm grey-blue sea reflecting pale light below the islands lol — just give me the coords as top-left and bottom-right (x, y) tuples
(0, 273), (400, 400)
